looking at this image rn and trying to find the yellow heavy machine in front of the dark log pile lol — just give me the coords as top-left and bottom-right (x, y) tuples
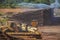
(0, 21), (42, 40)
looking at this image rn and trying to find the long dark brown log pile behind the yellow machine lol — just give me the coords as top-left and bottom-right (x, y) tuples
(12, 9), (51, 26)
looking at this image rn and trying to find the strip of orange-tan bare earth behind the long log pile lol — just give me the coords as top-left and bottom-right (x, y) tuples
(0, 8), (40, 13)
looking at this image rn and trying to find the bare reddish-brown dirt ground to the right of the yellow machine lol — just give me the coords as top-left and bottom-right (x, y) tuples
(38, 26), (60, 40)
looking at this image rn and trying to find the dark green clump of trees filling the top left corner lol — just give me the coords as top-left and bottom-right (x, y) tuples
(0, 0), (16, 8)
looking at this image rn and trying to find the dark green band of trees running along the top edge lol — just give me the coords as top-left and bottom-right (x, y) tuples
(0, 0), (60, 8)
